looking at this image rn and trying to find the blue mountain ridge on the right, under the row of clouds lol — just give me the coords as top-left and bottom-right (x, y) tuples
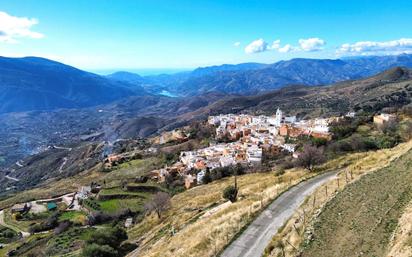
(160, 55), (412, 95)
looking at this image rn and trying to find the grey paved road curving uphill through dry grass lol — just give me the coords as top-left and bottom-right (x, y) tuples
(221, 171), (339, 257)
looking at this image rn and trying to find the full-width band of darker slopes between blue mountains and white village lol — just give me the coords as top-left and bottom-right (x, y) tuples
(0, 68), (412, 166)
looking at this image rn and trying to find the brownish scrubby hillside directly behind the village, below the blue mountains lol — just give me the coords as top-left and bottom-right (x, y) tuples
(182, 67), (412, 118)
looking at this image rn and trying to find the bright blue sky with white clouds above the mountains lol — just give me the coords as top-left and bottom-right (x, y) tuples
(0, 0), (412, 70)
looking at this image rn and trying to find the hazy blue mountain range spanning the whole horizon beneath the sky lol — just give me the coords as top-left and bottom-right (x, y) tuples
(0, 54), (412, 113)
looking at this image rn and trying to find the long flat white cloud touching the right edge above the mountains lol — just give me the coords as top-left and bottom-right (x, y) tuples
(337, 38), (412, 55)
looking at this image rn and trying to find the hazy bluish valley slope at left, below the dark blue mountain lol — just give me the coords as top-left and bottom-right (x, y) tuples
(0, 93), (224, 167)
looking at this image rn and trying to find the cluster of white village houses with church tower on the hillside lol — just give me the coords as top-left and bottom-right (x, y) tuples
(153, 109), (335, 188)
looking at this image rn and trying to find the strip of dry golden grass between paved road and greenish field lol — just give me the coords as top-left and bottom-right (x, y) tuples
(265, 141), (412, 257)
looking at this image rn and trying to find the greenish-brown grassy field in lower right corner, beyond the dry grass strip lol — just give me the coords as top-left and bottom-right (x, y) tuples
(302, 145), (412, 257)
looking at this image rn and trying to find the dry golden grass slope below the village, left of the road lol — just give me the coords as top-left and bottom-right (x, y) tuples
(125, 148), (387, 257)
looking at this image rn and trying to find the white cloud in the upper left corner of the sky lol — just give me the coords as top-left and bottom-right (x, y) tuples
(0, 11), (44, 43)
